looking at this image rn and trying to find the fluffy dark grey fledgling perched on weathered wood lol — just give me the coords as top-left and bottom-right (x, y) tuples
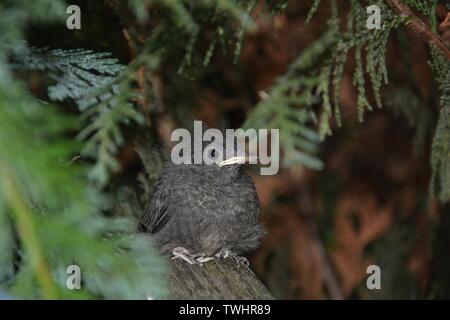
(139, 134), (265, 263)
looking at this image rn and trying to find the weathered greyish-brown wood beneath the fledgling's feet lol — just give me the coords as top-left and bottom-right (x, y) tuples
(168, 259), (274, 300)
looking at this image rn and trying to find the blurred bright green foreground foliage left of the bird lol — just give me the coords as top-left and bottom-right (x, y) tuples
(0, 1), (166, 299)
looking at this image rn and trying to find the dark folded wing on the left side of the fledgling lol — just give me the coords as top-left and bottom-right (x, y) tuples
(138, 179), (169, 233)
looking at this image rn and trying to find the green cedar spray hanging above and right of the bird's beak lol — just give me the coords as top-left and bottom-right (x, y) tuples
(247, 1), (402, 169)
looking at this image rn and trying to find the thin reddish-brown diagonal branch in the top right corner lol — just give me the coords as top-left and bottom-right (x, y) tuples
(386, 0), (450, 60)
